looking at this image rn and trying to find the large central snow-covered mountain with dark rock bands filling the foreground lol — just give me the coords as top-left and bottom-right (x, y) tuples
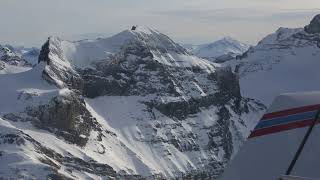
(0, 27), (265, 179)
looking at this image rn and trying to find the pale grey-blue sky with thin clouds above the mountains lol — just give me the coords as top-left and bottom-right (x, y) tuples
(0, 0), (320, 46)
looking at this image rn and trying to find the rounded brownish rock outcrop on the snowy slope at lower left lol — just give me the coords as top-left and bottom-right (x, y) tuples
(27, 92), (102, 146)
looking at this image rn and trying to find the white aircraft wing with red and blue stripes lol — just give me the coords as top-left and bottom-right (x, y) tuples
(219, 92), (320, 180)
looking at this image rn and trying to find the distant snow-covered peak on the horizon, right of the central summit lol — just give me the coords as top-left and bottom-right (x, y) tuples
(185, 37), (250, 62)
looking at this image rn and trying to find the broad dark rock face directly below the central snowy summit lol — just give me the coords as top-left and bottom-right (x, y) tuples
(80, 39), (177, 97)
